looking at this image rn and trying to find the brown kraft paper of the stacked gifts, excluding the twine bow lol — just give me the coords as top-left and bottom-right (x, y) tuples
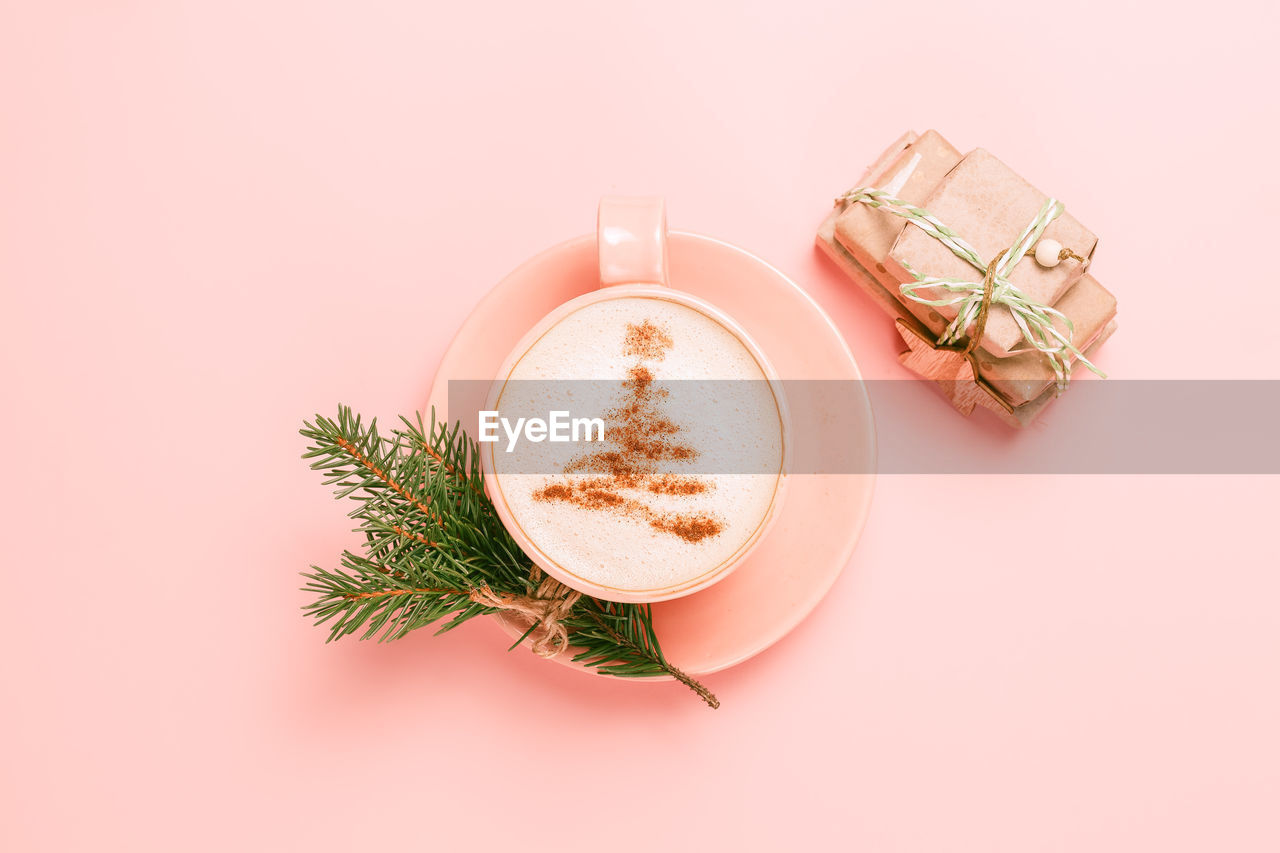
(818, 131), (1116, 425)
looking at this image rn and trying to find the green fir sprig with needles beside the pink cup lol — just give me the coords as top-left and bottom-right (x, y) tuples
(300, 406), (719, 708)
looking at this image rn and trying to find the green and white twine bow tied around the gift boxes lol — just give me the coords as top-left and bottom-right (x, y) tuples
(836, 187), (1106, 393)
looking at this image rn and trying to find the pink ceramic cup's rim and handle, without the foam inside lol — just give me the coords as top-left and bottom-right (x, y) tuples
(480, 196), (791, 602)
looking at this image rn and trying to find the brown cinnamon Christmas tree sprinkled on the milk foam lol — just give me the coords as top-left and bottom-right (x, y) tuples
(534, 320), (724, 542)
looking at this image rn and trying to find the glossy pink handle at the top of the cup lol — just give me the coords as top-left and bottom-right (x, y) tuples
(595, 196), (667, 287)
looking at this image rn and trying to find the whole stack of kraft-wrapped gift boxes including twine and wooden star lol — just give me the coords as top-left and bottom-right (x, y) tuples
(818, 131), (1116, 427)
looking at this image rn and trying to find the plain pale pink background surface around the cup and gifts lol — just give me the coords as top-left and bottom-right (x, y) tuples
(0, 0), (1280, 852)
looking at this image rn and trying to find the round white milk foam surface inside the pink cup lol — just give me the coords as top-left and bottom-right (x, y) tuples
(493, 296), (783, 592)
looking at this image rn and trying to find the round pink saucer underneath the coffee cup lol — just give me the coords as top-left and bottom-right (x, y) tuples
(428, 232), (876, 675)
